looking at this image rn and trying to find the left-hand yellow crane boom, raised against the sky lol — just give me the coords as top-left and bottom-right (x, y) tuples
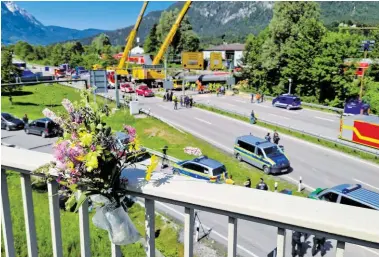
(103, 1), (149, 76)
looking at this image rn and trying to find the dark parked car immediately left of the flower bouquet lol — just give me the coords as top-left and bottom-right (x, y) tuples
(25, 118), (63, 137)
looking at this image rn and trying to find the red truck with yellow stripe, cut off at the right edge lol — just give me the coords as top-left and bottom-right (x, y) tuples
(339, 115), (379, 149)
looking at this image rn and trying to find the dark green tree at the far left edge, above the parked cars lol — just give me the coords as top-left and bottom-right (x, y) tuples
(1, 48), (22, 104)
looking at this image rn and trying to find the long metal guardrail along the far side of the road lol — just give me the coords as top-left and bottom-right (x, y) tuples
(195, 103), (379, 158)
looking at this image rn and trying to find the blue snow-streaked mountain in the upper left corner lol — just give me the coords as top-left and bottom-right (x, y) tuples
(1, 1), (103, 45)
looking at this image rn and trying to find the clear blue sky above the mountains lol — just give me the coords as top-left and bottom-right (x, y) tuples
(15, 1), (174, 30)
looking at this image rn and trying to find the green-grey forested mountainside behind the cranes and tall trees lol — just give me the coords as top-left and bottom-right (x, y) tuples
(81, 1), (379, 45)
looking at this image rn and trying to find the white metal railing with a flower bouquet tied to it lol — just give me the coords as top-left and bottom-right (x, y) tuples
(1, 146), (379, 257)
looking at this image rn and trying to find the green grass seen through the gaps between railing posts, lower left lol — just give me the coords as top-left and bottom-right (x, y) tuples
(2, 172), (183, 257)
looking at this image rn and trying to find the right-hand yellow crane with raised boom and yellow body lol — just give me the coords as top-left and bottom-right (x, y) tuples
(133, 1), (192, 80)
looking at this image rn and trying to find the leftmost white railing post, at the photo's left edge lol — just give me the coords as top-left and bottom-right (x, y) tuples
(1, 169), (16, 257)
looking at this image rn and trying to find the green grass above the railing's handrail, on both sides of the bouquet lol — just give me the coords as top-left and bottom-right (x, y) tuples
(2, 84), (305, 196)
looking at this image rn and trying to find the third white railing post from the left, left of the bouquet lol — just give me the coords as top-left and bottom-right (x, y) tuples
(47, 180), (63, 257)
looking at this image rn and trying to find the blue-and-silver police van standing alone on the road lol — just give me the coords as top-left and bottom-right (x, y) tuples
(234, 135), (292, 174)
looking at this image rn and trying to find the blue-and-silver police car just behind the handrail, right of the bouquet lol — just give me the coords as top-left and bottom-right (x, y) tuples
(173, 156), (228, 182)
